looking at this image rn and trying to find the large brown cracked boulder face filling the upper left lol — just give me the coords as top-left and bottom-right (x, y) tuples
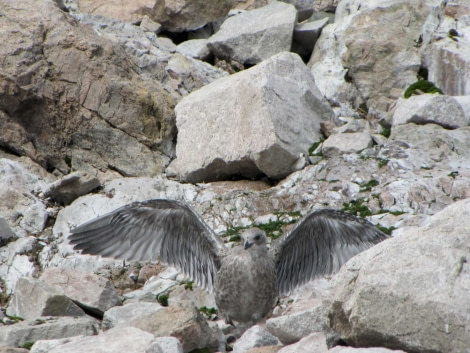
(0, 0), (175, 175)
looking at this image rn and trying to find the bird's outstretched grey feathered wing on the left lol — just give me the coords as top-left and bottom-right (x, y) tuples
(69, 200), (224, 291)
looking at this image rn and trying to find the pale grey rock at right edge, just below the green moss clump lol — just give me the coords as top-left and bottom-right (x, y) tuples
(392, 94), (470, 129)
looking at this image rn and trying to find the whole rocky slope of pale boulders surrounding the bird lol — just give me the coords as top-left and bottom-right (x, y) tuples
(0, 0), (470, 353)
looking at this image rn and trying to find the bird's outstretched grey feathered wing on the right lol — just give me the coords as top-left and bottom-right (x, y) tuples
(274, 209), (388, 295)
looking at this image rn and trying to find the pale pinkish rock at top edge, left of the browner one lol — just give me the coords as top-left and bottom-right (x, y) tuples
(77, 0), (155, 23)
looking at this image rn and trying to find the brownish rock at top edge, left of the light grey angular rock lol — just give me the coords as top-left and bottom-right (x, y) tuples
(151, 0), (233, 32)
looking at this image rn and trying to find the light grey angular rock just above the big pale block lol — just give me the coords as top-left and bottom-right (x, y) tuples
(208, 1), (297, 65)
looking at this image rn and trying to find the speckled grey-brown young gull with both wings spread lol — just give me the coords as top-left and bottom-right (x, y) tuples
(69, 199), (389, 326)
